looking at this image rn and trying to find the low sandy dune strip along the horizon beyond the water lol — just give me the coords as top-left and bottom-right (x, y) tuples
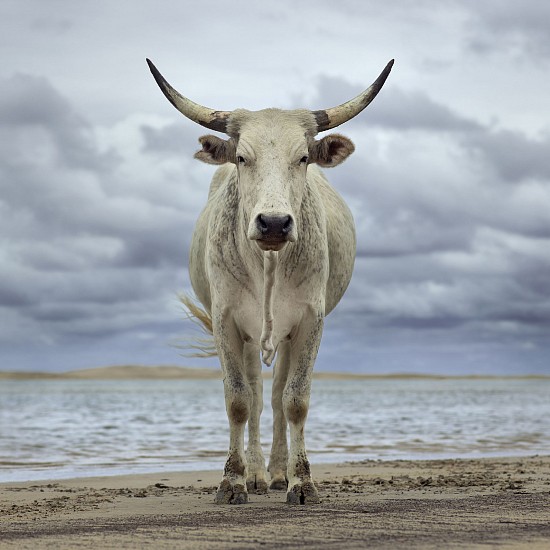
(0, 365), (550, 380)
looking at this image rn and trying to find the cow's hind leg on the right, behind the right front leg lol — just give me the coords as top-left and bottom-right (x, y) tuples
(268, 341), (290, 491)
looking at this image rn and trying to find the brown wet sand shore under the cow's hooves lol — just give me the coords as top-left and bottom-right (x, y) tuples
(0, 456), (550, 549)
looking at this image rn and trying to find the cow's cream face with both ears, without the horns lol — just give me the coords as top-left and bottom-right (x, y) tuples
(195, 109), (354, 251)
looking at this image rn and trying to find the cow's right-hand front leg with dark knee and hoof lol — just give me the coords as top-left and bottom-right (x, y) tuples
(283, 310), (323, 504)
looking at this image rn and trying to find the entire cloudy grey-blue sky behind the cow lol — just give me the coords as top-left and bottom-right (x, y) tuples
(0, 0), (550, 374)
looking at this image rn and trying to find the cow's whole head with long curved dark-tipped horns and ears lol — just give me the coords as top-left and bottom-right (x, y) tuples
(147, 60), (393, 250)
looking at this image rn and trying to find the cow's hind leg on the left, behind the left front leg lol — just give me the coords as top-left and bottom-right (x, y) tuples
(244, 343), (267, 495)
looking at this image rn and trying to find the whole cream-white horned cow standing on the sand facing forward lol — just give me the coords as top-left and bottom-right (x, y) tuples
(147, 59), (393, 504)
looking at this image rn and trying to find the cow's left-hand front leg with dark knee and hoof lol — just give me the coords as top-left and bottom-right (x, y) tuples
(214, 308), (252, 504)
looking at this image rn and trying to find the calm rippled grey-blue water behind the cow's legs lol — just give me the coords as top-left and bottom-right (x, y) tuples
(0, 380), (550, 481)
